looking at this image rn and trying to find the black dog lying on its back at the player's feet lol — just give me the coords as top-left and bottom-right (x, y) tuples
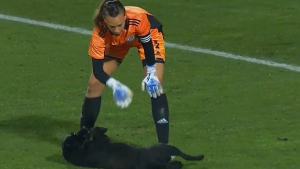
(62, 127), (204, 169)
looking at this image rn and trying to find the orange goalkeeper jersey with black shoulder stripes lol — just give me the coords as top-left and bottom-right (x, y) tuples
(88, 6), (162, 59)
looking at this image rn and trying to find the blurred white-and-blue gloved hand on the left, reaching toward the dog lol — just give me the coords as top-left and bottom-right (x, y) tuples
(106, 77), (133, 109)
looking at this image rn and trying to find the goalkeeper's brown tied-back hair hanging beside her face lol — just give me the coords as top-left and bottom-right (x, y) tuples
(94, 0), (125, 27)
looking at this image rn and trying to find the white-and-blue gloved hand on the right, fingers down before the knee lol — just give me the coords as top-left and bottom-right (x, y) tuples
(142, 65), (163, 98)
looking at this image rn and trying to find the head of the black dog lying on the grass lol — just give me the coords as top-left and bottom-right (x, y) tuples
(62, 128), (89, 151)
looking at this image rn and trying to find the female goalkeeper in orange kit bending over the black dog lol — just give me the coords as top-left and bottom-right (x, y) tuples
(80, 0), (169, 144)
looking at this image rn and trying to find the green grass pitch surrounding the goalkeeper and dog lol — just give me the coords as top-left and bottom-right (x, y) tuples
(0, 0), (300, 169)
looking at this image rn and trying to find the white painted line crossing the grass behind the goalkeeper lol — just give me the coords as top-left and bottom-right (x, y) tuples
(0, 14), (300, 72)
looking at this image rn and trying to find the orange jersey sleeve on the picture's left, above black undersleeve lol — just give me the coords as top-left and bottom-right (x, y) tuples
(88, 28), (105, 59)
